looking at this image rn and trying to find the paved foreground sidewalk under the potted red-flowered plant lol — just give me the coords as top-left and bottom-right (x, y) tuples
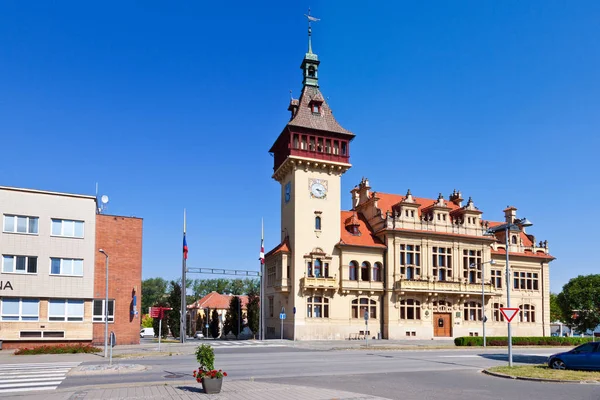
(0, 381), (386, 400)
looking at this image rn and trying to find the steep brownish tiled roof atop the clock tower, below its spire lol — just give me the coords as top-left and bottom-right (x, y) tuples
(288, 86), (354, 136)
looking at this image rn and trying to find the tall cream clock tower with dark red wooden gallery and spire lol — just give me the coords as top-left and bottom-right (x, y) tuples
(264, 16), (354, 339)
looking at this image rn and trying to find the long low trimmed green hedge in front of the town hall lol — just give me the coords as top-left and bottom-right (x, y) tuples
(454, 336), (594, 346)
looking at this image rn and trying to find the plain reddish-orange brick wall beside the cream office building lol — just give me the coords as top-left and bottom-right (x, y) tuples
(93, 214), (142, 344)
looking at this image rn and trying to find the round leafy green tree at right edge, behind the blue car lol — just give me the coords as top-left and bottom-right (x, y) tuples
(557, 274), (600, 332)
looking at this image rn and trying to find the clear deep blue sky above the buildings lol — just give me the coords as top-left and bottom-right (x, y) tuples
(0, 0), (600, 291)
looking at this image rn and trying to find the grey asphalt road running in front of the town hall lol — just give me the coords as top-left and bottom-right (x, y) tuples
(60, 347), (600, 400)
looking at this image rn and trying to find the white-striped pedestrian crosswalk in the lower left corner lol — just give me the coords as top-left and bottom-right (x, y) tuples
(0, 362), (80, 393)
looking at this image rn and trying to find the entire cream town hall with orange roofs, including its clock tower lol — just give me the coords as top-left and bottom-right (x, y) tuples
(264, 28), (554, 340)
